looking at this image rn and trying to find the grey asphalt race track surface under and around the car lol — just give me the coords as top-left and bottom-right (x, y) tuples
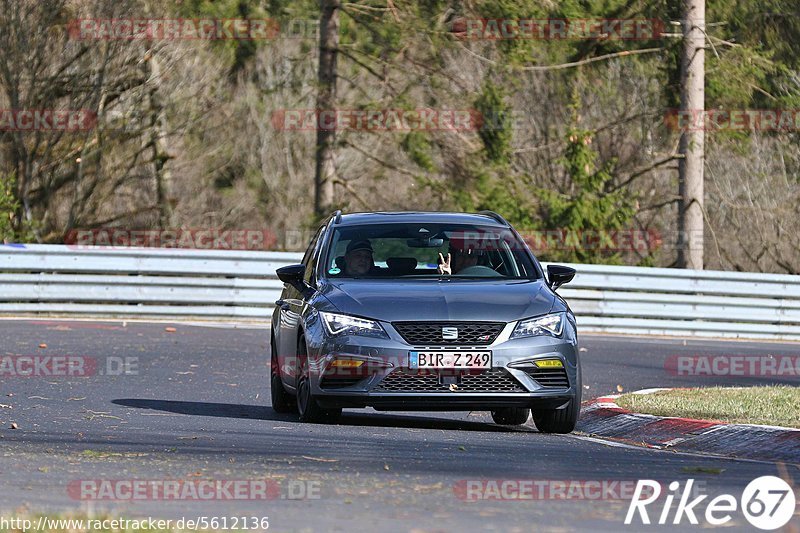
(0, 320), (800, 531)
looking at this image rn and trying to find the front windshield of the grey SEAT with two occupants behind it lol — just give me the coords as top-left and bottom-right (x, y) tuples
(323, 223), (540, 279)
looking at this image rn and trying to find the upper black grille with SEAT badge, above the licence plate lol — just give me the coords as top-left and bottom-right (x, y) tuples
(392, 322), (505, 346)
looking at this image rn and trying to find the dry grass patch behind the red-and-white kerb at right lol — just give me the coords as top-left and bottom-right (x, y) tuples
(617, 386), (800, 428)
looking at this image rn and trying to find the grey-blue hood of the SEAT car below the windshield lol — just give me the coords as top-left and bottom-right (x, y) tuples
(321, 279), (555, 322)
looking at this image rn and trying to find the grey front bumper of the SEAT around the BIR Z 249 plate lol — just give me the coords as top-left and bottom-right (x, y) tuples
(307, 323), (580, 411)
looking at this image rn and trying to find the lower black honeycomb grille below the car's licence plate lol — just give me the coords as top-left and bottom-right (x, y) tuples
(373, 368), (527, 393)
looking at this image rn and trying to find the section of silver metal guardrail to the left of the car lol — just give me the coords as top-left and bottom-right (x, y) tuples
(0, 245), (292, 323)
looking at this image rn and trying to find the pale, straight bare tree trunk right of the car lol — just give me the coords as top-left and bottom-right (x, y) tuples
(678, 0), (706, 270)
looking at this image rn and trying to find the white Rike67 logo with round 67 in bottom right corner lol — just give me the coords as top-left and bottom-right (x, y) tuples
(625, 476), (796, 531)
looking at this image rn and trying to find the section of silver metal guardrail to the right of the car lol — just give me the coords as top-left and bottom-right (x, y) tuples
(558, 265), (800, 341)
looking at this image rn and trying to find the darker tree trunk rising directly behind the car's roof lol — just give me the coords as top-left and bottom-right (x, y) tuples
(314, 0), (341, 218)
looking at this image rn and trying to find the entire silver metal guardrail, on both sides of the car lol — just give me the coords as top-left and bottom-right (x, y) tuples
(0, 245), (800, 340)
